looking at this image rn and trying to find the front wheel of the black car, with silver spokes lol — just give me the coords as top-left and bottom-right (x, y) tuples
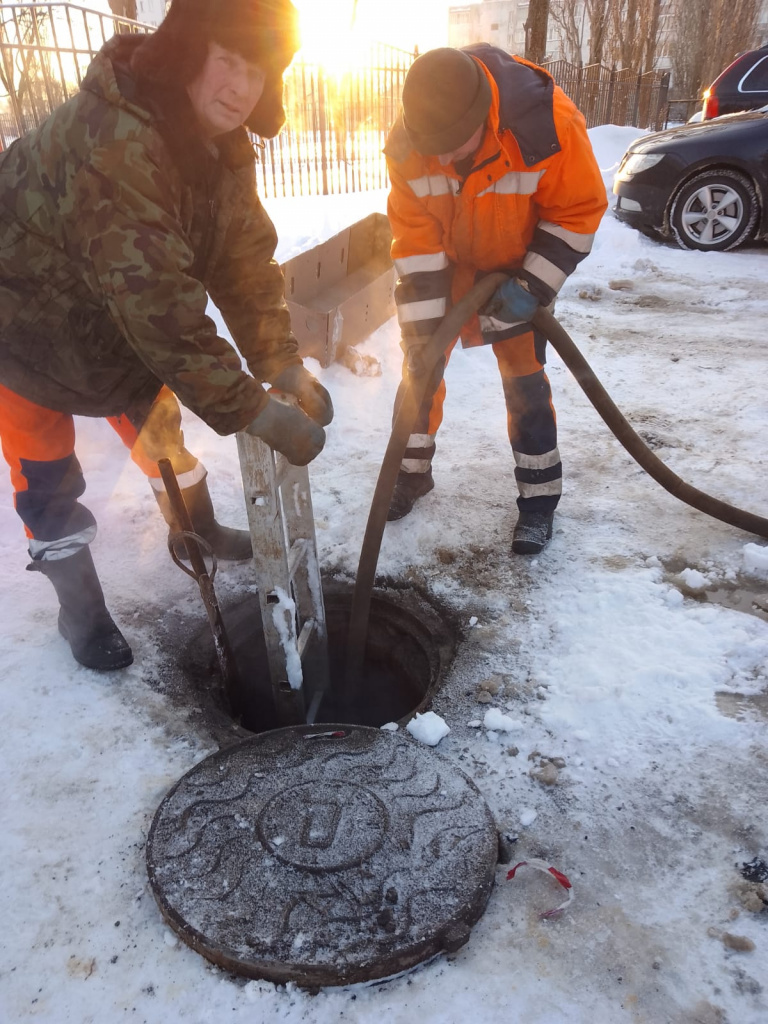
(670, 170), (759, 252)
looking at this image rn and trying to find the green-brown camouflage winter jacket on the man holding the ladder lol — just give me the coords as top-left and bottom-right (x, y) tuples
(0, 37), (301, 434)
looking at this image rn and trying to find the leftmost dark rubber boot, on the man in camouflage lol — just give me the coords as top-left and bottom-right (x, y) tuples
(27, 545), (133, 672)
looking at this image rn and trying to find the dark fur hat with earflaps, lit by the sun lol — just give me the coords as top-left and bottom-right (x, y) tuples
(131, 0), (299, 138)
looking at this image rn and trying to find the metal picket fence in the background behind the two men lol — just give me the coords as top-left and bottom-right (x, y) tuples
(0, 3), (669, 197)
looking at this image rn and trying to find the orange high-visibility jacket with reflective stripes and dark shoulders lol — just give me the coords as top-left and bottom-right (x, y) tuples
(384, 43), (608, 347)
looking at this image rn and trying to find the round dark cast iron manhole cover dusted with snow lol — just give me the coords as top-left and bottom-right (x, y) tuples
(146, 725), (498, 987)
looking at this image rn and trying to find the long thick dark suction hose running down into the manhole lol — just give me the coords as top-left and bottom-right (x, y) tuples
(345, 273), (768, 687)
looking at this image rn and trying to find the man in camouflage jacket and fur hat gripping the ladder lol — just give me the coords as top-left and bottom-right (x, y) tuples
(0, 0), (333, 669)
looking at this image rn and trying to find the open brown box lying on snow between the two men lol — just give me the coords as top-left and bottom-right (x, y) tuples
(283, 213), (396, 367)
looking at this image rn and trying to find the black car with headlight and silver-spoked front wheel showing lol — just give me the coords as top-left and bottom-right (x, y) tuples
(613, 106), (768, 252)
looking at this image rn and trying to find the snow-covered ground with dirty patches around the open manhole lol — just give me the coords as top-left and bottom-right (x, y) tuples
(0, 127), (768, 1024)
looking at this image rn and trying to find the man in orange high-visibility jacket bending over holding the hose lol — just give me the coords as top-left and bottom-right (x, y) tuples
(384, 43), (607, 554)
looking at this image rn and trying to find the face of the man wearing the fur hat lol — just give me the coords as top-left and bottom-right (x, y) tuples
(186, 43), (265, 138)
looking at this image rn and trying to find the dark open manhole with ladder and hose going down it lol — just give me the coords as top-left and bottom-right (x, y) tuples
(181, 584), (455, 732)
